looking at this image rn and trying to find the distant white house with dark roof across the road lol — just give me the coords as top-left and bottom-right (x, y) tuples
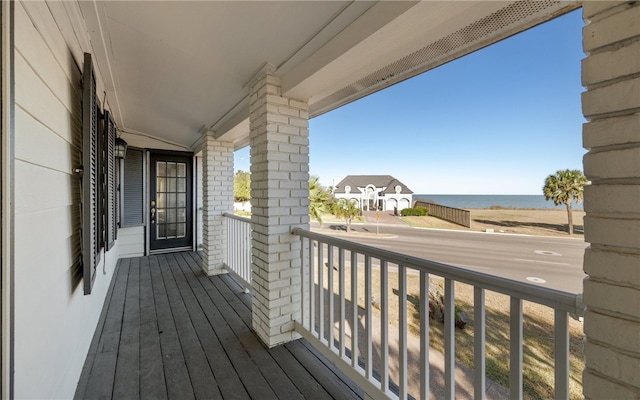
(334, 175), (413, 211)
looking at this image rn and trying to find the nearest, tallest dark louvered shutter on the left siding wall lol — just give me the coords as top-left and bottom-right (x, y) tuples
(82, 53), (101, 294)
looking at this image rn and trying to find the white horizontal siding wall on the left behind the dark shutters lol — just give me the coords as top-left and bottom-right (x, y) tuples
(14, 2), (118, 398)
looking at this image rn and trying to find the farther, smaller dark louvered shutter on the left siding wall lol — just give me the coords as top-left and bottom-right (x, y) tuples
(103, 111), (118, 251)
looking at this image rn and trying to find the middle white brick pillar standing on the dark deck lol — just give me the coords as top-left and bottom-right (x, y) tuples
(250, 73), (309, 347)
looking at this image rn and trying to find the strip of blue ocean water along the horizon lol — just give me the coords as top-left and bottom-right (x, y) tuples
(413, 194), (583, 210)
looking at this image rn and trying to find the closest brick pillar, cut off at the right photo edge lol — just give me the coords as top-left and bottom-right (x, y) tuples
(582, 1), (640, 399)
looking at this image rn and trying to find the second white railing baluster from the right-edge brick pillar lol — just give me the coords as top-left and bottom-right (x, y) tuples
(509, 296), (522, 399)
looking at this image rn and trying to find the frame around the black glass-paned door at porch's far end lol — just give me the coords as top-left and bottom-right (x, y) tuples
(144, 149), (198, 255)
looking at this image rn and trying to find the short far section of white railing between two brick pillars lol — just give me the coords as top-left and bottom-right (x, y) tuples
(222, 213), (251, 293)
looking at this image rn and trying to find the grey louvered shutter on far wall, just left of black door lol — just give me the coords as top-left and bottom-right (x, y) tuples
(121, 148), (144, 226)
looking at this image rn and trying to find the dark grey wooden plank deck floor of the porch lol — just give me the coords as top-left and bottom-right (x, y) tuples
(75, 252), (362, 399)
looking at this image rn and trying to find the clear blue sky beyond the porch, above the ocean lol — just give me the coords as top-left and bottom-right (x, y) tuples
(235, 9), (585, 194)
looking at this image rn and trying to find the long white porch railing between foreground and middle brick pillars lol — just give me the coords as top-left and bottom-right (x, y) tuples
(291, 228), (582, 399)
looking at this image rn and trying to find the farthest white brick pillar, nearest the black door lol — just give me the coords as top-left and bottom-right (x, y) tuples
(202, 136), (233, 275)
